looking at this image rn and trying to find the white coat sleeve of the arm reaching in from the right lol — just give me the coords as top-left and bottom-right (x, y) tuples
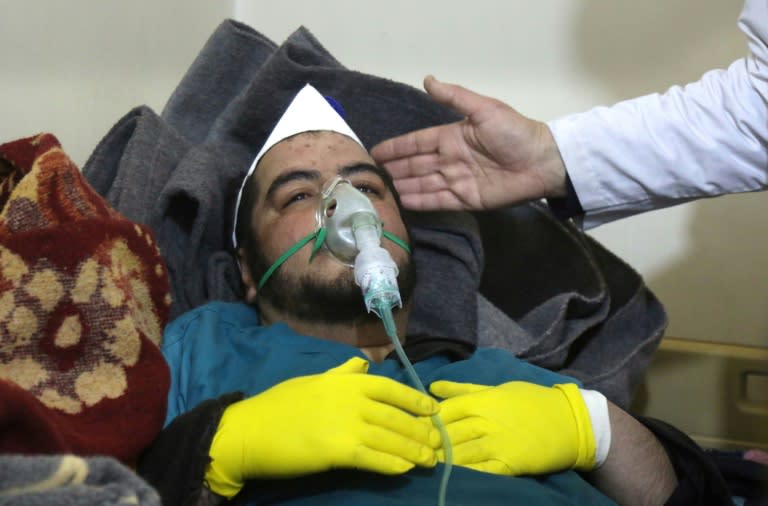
(548, 0), (768, 228)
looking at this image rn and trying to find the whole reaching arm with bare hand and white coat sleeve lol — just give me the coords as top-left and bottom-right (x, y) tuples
(371, 0), (768, 228)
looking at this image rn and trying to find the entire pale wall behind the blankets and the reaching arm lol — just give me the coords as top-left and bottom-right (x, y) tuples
(0, 0), (768, 343)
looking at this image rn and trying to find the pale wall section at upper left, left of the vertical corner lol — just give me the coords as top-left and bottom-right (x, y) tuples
(0, 0), (233, 166)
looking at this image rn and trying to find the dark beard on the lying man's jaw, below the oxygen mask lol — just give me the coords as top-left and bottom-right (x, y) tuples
(248, 245), (416, 324)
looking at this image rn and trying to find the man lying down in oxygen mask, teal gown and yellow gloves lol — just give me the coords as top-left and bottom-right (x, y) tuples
(139, 85), (728, 506)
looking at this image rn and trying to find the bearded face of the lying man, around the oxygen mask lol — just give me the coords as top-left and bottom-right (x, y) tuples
(241, 132), (413, 323)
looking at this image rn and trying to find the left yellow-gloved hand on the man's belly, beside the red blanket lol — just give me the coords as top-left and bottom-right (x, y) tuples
(205, 357), (440, 497)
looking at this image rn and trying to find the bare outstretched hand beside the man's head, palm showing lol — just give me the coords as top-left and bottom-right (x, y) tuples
(371, 76), (565, 211)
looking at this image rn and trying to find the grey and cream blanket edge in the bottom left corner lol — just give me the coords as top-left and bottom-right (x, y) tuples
(0, 455), (160, 506)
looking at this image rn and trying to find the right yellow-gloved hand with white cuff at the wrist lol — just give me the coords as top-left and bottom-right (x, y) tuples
(430, 381), (610, 476)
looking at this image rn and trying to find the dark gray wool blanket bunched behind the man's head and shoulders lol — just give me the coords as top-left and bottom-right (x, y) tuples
(83, 20), (666, 406)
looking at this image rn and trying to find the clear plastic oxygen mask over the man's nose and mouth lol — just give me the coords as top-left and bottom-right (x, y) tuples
(317, 177), (402, 317)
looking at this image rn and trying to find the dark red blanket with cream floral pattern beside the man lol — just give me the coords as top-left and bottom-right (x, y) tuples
(0, 134), (171, 462)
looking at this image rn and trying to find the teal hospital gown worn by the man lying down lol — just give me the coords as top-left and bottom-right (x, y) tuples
(162, 302), (613, 506)
